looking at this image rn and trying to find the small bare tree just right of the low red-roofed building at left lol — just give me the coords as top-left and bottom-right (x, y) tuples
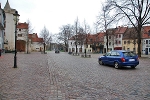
(40, 26), (52, 54)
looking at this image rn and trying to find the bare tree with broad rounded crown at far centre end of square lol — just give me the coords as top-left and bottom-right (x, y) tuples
(58, 24), (73, 52)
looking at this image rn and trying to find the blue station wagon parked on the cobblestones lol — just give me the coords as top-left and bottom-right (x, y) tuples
(98, 50), (139, 68)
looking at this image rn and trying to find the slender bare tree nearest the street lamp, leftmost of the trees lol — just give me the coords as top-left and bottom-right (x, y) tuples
(26, 19), (34, 54)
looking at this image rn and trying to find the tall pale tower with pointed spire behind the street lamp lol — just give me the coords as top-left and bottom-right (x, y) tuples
(4, 0), (19, 50)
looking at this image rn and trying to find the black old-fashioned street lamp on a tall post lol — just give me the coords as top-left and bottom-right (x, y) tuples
(13, 11), (20, 68)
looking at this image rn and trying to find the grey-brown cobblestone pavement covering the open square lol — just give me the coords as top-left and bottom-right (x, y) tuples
(0, 52), (150, 100)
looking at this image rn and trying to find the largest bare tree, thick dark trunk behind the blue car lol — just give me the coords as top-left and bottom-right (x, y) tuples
(108, 0), (150, 57)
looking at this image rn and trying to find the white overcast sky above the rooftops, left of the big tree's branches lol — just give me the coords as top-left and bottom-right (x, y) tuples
(0, 0), (104, 34)
